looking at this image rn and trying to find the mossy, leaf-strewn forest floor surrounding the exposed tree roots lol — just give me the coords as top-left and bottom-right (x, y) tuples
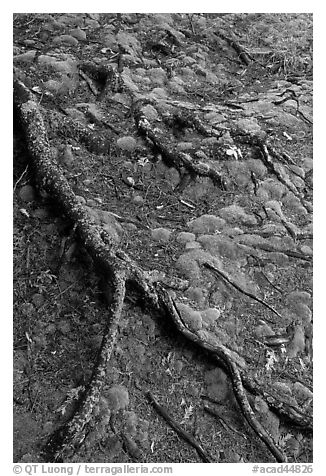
(14, 14), (312, 463)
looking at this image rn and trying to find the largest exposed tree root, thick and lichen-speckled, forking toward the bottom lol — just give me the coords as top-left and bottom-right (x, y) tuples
(14, 80), (309, 462)
